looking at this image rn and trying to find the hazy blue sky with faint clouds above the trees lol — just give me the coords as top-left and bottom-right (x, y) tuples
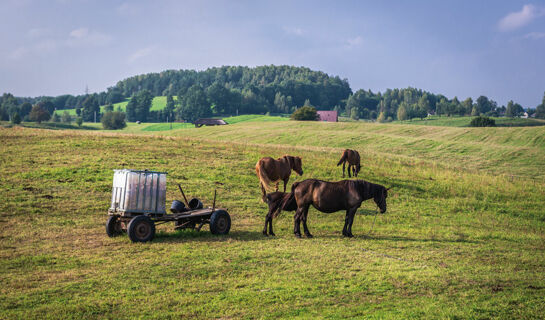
(0, 0), (545, 107)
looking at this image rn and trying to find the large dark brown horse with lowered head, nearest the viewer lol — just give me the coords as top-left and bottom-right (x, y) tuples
(291, 179), (389, 238)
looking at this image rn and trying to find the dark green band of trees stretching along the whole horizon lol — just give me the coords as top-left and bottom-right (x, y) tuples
(0, 65), (545, 122)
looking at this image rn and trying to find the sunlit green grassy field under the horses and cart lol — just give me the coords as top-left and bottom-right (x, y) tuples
(0, 121), (545, 319)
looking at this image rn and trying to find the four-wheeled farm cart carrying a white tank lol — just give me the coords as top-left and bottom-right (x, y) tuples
(106, 169), (231, 242)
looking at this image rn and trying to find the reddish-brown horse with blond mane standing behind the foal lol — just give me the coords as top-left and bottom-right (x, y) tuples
(255, 156), (303, 201)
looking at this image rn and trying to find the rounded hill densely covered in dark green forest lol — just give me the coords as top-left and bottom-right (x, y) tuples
(115, 65), (352, 113)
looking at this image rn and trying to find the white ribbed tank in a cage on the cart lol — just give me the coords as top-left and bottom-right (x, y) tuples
(110, 169), (167, 214)
